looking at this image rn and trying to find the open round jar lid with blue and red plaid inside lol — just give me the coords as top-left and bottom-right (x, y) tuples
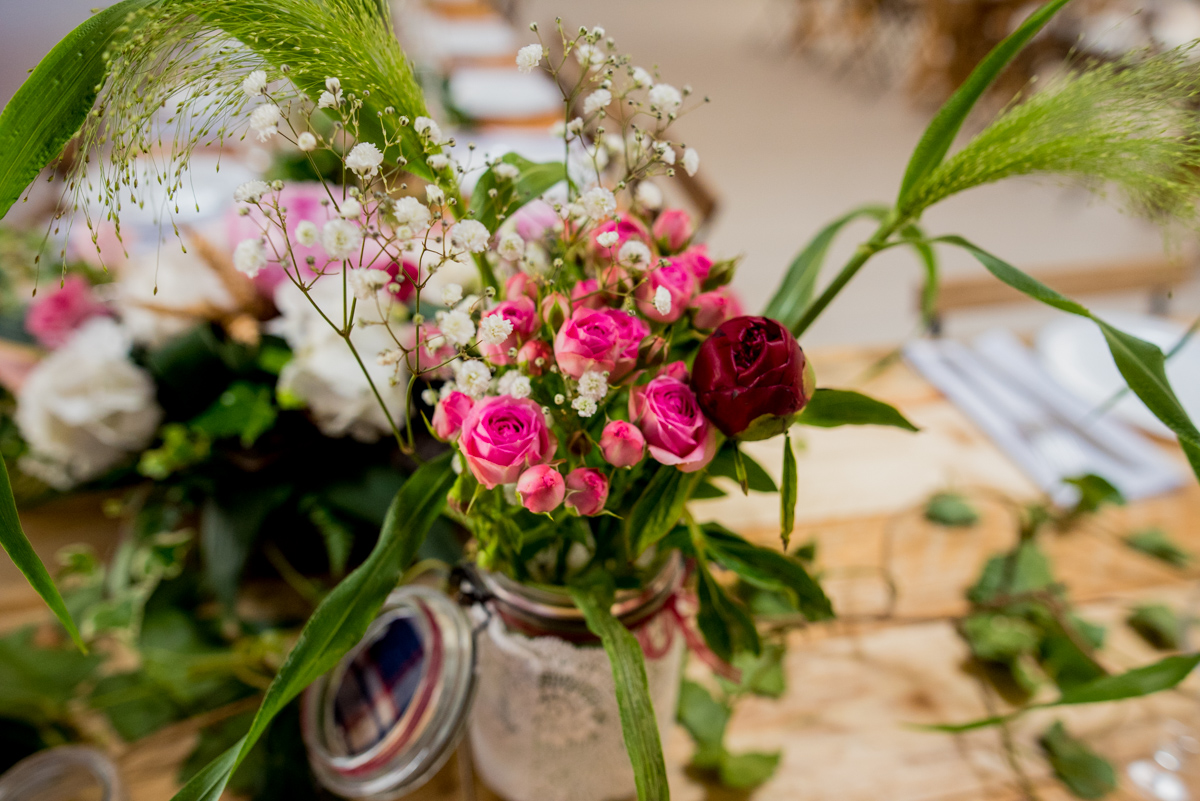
(301, 585), (475, 801)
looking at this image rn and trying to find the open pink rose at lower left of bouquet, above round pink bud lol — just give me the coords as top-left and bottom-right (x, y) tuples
(458, 395), (558, 489)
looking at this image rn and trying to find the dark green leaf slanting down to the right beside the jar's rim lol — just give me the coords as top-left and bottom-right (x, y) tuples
(702, 523), (834, 620)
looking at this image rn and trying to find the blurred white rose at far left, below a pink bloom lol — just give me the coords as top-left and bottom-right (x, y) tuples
(14, 317), (162, 489)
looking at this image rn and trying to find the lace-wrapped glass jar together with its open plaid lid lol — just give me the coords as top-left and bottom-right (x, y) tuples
(301, 553), (684, 801)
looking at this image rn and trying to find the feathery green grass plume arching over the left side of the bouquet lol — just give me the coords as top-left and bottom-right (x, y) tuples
(67, 0), (449, 251)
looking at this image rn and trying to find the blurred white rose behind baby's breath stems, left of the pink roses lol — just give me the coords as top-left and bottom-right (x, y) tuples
(271, 279), (408, 442)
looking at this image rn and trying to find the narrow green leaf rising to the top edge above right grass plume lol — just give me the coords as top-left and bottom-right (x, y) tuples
(896, 0), (1069, 211)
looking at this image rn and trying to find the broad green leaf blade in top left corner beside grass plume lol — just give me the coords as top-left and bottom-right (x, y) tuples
(0, 0), (157, 218)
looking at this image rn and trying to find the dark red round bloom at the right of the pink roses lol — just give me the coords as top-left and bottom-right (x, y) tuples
(691, 317), (815, 440)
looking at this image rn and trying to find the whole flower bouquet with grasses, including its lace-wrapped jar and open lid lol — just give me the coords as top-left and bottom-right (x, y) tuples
(7, 0), (1200, 799)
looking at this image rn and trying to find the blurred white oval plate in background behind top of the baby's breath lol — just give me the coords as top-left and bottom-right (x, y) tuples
(450, 66), (563, 120)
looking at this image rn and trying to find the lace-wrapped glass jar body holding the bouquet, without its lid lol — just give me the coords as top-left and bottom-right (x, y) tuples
(468, 554), (684, 801)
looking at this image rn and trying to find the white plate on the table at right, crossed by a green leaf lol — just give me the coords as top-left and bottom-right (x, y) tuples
(1037, 312), (1200, 438)
